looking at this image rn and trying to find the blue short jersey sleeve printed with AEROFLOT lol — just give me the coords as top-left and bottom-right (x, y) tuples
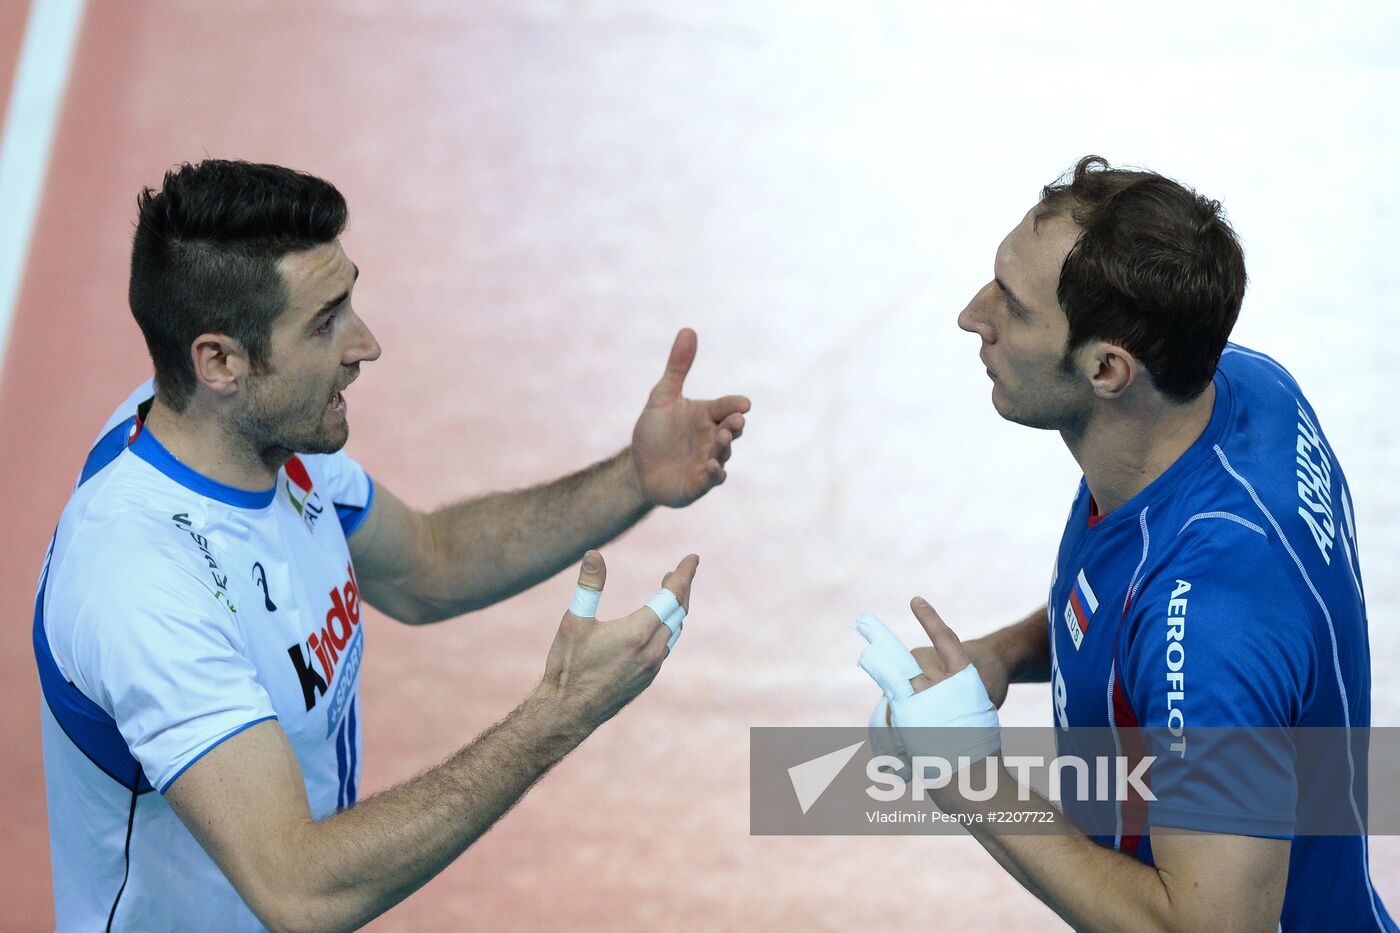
(1119, 518), (1317, 838)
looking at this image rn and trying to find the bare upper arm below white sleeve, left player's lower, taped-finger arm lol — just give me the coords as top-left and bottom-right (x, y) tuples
(164, 720), (312, 929)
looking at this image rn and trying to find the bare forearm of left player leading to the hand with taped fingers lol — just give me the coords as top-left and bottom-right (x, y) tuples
(281, 693), (588, 930)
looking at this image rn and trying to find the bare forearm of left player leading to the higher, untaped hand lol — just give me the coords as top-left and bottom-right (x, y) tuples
(414, 448), (651, 622)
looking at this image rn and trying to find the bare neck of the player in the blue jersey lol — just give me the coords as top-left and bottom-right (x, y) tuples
(1060, 382), (1215, 514)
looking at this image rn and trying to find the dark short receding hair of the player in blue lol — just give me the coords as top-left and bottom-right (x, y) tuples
(1035, 156), (1245, 401)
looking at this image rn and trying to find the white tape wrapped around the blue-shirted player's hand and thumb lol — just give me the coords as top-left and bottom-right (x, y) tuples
(855, 612), (1001, 770)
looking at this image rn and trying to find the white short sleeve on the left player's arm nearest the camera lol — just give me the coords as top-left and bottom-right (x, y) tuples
(48, 537), (274, 793)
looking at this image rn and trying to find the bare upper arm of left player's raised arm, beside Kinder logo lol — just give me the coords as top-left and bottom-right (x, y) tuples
(349, 483), (433, 622)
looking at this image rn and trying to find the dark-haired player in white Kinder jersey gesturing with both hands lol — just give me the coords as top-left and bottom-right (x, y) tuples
(34, 160), (749, 930)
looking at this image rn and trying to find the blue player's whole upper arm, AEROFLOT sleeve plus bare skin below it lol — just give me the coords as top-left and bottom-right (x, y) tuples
(1120, 521), (1315, 930)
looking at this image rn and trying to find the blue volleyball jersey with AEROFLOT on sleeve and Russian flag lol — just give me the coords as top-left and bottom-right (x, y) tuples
(1047, 345), (1396, 930)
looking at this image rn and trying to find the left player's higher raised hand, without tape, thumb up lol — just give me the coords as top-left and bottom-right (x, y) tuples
(631, 328), (750, 509)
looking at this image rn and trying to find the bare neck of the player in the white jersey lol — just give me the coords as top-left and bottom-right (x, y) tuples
(144, 396), (287, 492)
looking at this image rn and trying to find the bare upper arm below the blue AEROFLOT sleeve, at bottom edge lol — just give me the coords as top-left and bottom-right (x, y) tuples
(1152, 829), (1292, 930)
